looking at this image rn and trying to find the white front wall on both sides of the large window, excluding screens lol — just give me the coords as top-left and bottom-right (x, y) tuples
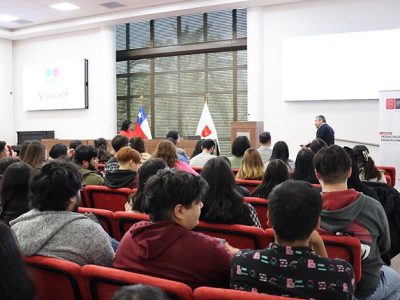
(0, 0), (400, 162)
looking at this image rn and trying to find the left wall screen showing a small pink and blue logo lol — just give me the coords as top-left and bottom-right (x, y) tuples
(23, 58), (88, 111)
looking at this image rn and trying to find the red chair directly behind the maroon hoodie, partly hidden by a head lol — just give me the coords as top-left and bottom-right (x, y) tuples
(82, 265), (193, 300)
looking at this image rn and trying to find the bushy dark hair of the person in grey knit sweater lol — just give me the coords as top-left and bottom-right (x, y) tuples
(29, 160), (82, 211)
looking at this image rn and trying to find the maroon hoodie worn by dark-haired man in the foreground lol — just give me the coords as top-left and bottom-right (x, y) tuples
(113, 221), (232, 287)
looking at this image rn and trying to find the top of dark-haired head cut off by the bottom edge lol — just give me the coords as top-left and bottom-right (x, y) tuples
(111, 284), (167, 300)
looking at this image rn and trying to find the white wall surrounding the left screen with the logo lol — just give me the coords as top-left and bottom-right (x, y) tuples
(12, 27), (117, 142)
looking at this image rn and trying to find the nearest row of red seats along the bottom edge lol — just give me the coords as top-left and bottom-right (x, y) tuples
(24, 256), (304, 300)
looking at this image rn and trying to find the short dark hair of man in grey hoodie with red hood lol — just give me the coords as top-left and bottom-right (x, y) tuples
(313, 145), (351, 183)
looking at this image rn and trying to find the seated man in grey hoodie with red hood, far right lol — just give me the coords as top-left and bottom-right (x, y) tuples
(314, 145), (400, 300)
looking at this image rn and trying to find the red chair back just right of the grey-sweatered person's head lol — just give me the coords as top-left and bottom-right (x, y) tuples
(83, 185), (136, 211)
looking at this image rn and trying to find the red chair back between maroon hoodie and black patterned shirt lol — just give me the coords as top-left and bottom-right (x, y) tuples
(193, 221), (266, 249)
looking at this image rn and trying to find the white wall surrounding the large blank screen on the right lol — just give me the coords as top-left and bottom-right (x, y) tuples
(248, 0), (400, 163)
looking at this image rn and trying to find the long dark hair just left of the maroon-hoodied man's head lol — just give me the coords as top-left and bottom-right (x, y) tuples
(129, 158), (167, 212)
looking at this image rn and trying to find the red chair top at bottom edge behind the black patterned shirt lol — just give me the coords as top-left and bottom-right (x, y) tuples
(193, 287), (299, 300)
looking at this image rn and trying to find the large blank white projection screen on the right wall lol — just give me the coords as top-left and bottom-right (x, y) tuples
(282, 29), (400, 101)
